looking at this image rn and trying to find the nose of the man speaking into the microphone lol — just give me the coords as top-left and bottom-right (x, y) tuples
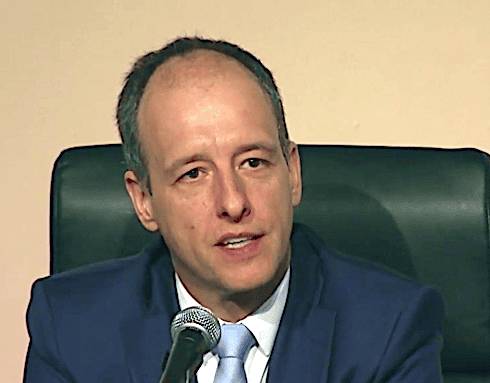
(216, 172), (251, 222)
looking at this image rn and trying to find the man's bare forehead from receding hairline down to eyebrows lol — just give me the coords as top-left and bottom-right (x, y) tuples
(138, 51), (277, 165)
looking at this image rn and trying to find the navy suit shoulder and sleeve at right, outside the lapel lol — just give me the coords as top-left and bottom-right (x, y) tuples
(290, 225), (444, 382)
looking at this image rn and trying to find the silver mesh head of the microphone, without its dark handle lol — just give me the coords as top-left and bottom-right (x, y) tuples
(170, 306), (221, 350)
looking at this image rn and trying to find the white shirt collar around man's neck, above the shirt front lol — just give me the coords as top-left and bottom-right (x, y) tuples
(175, 268), (290, 356)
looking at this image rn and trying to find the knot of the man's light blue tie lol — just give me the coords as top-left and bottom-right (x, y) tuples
(215, 324), (255, 362)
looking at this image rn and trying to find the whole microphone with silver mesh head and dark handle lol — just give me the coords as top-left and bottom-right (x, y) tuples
(160, 306), (221, 383)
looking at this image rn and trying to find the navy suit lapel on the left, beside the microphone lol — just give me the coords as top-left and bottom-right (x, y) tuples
(121, 245), (179, 383)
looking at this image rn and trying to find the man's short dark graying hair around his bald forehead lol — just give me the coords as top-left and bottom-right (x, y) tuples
(116, 37), (289, 187)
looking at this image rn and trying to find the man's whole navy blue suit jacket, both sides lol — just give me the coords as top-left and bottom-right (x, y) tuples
(24, 225), (443, 383)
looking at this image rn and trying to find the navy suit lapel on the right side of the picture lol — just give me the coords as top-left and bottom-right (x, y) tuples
(267, 227), (335, 383)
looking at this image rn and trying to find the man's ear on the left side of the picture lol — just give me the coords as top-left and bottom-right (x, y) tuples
(124, 170), (158, 231)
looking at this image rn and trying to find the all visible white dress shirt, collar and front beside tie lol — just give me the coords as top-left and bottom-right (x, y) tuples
(175, 268), (290, 383)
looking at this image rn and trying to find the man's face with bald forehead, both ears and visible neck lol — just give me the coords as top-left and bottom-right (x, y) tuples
(126, 52), (301, 304)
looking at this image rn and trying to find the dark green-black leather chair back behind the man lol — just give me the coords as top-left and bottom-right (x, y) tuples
(51, 145), (490, 383)
